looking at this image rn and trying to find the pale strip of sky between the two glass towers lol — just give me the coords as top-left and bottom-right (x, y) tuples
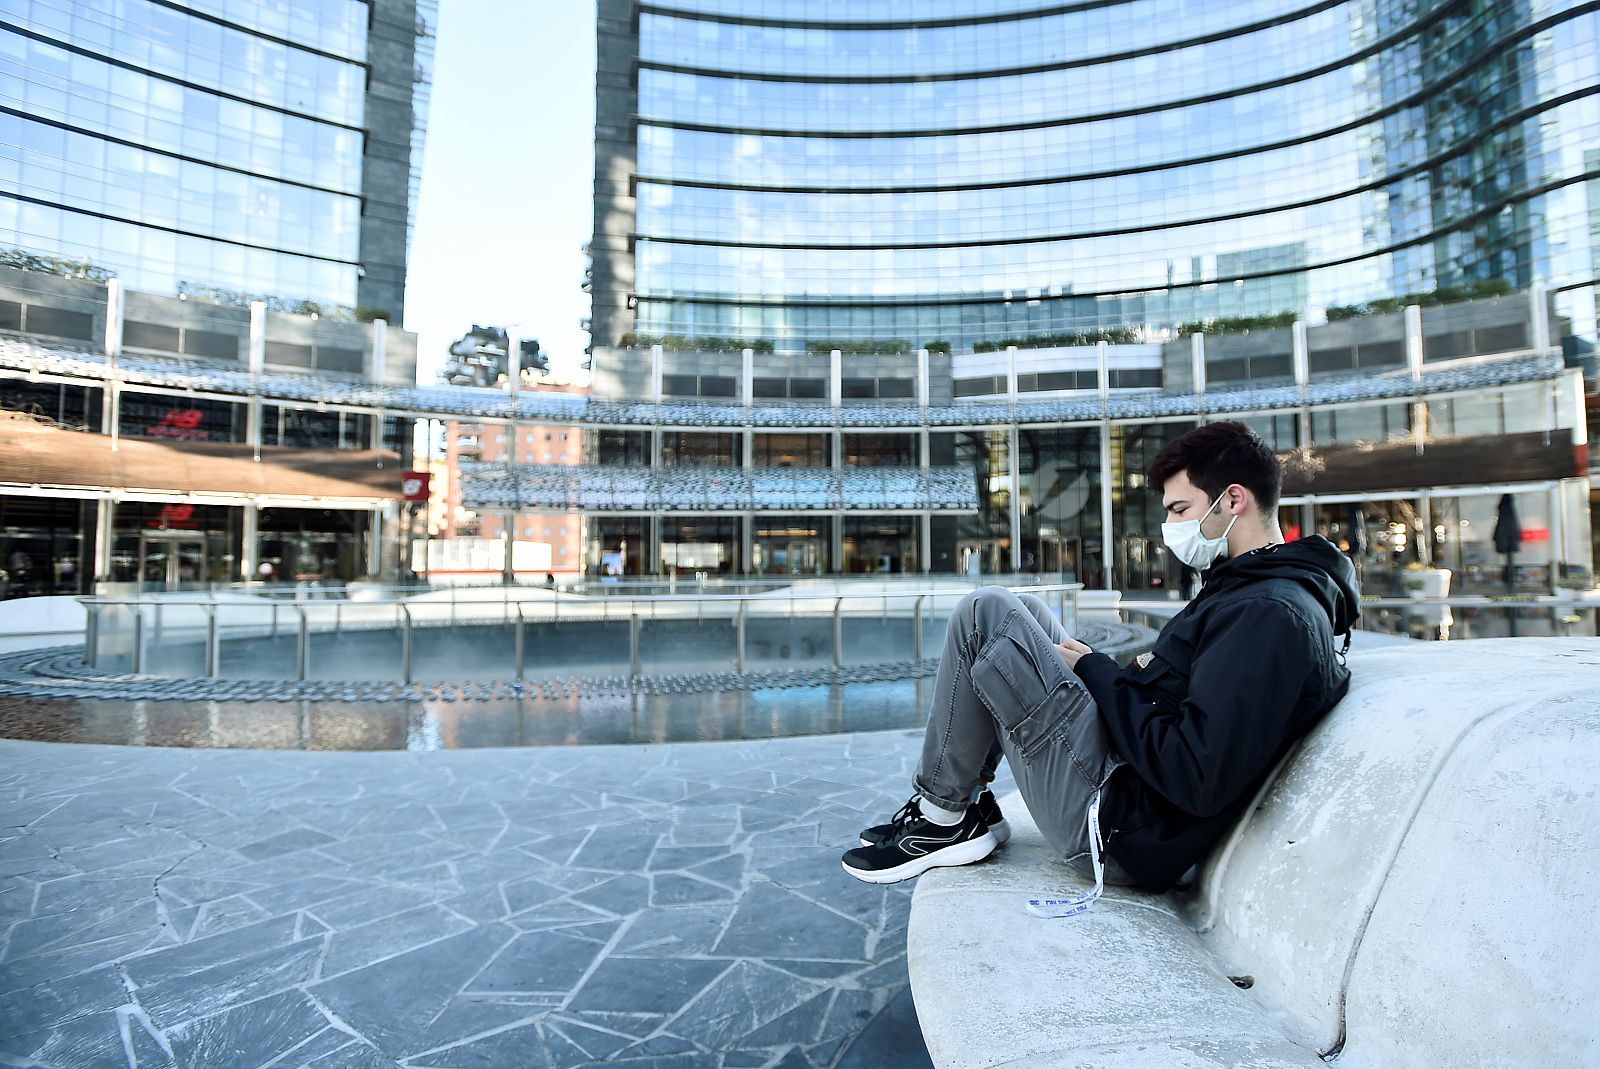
(405, 0), (595, 382)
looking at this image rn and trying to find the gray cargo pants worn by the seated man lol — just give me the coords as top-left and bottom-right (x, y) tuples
(915, 586), (1131, 883)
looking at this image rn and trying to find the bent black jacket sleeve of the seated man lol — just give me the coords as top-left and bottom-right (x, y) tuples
(1077, 599), (1315, 816)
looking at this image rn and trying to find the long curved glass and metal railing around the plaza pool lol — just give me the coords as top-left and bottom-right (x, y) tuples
(78, 578), (1082, 683)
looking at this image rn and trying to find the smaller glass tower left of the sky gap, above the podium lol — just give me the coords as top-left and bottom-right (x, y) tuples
(0, 0), (437, 322)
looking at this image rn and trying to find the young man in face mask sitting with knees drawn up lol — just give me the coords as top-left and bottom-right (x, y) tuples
(845, 421), (1360, 896)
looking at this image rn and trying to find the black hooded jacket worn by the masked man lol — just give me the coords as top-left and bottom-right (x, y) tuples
(1077, 535), (1360, 891)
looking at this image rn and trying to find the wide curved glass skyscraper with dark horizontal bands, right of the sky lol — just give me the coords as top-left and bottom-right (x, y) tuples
(592, 0), (1600, 358)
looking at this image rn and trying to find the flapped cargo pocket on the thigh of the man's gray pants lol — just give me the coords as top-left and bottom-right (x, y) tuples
(971, 610), (1093, 760)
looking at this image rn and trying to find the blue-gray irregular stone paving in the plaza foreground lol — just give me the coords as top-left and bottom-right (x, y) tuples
(0, 731), (1011, 1069)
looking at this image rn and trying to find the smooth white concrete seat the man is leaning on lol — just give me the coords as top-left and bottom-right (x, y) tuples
(907, 639), (1600, 1069)
